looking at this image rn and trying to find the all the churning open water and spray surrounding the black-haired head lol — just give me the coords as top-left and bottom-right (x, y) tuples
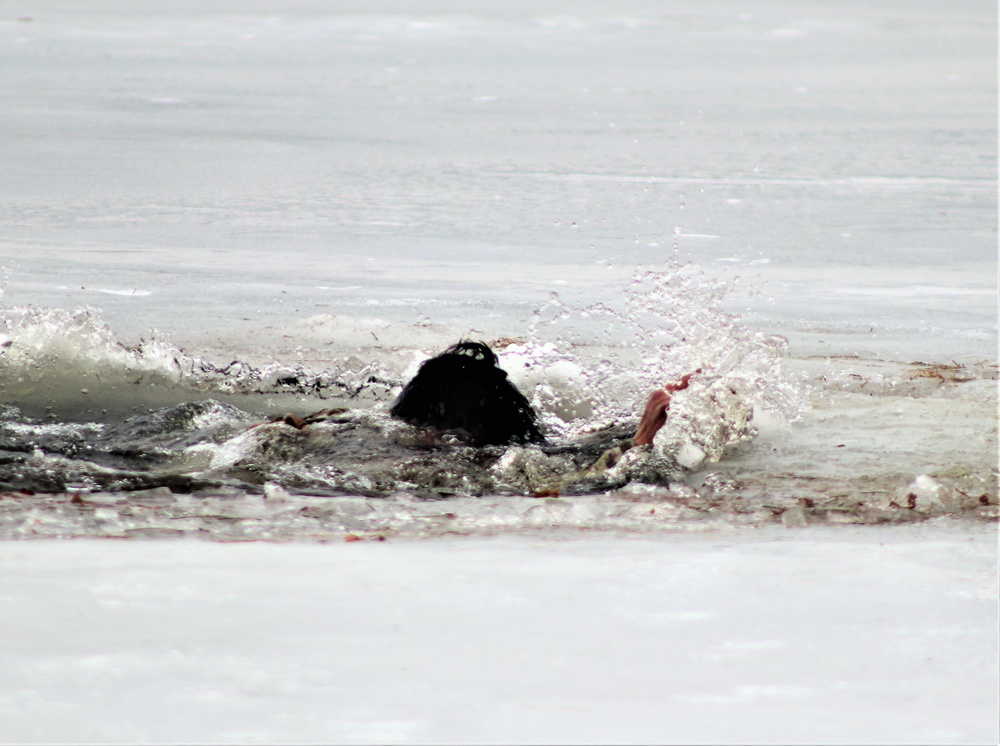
(0, 258), (800, 496)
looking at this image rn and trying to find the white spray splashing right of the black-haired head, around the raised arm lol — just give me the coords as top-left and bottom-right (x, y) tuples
(501, 265), (806, 463)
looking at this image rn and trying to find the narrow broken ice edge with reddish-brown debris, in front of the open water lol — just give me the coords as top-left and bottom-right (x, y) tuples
(0, 480), (998, 541)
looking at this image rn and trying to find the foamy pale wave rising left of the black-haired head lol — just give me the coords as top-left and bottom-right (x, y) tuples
(0, 307), (398, 421)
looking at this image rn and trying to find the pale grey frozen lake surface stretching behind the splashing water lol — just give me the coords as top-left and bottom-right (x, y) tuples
(0, 0), (996, 361)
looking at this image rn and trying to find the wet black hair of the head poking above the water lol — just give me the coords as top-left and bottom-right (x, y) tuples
(389, 341), (544, 446)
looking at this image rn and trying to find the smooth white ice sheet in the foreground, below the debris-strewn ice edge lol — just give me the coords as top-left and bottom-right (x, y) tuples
(0, 522), (998, 743)
